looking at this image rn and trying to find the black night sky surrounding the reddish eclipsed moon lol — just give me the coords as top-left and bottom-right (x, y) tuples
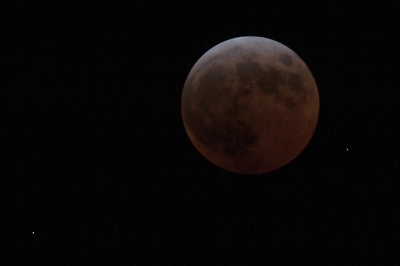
(0, 1), (400, 265)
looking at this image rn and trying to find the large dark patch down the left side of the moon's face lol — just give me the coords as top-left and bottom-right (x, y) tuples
(183, 61), (258, 158)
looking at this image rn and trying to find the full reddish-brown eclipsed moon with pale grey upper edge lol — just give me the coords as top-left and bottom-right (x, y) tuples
(181, 36), (319, 175)
